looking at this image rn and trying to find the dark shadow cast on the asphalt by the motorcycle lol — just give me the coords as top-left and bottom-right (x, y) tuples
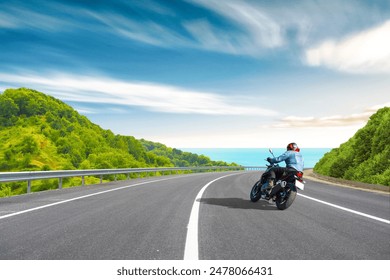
(197, 197), (278, 210)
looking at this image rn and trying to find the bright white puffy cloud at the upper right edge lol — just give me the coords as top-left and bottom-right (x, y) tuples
(305, 20), (390, 74)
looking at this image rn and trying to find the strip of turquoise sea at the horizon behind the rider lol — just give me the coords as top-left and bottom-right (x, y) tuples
(179, 148), (332, 168)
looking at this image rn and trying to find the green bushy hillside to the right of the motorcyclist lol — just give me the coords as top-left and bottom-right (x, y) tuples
(314, 107), (390, 186)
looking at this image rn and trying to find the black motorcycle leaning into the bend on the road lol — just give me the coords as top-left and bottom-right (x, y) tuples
(250, 149), (305, 210)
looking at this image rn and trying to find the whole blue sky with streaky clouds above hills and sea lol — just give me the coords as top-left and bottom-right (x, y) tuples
(0, 0), (390, 148)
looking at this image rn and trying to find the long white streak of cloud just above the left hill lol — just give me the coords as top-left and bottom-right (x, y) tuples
(0, 73), (277, 116)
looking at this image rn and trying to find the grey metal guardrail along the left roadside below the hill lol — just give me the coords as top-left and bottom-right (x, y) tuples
(0, 166), (263, 193)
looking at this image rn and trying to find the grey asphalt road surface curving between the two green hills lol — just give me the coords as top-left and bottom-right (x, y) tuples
(0, 172), (390, 260)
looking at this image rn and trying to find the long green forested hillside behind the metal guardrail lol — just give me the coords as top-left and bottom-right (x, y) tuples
(0, 88), (235, 196)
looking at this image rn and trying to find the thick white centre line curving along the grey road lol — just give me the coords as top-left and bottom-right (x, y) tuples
(184, 174), (237, 260)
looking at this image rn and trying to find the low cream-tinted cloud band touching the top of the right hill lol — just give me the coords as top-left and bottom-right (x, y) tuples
(271, 102), (390, 128)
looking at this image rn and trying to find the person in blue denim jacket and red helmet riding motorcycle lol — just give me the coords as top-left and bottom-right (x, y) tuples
(267, 143), (303, 189)
